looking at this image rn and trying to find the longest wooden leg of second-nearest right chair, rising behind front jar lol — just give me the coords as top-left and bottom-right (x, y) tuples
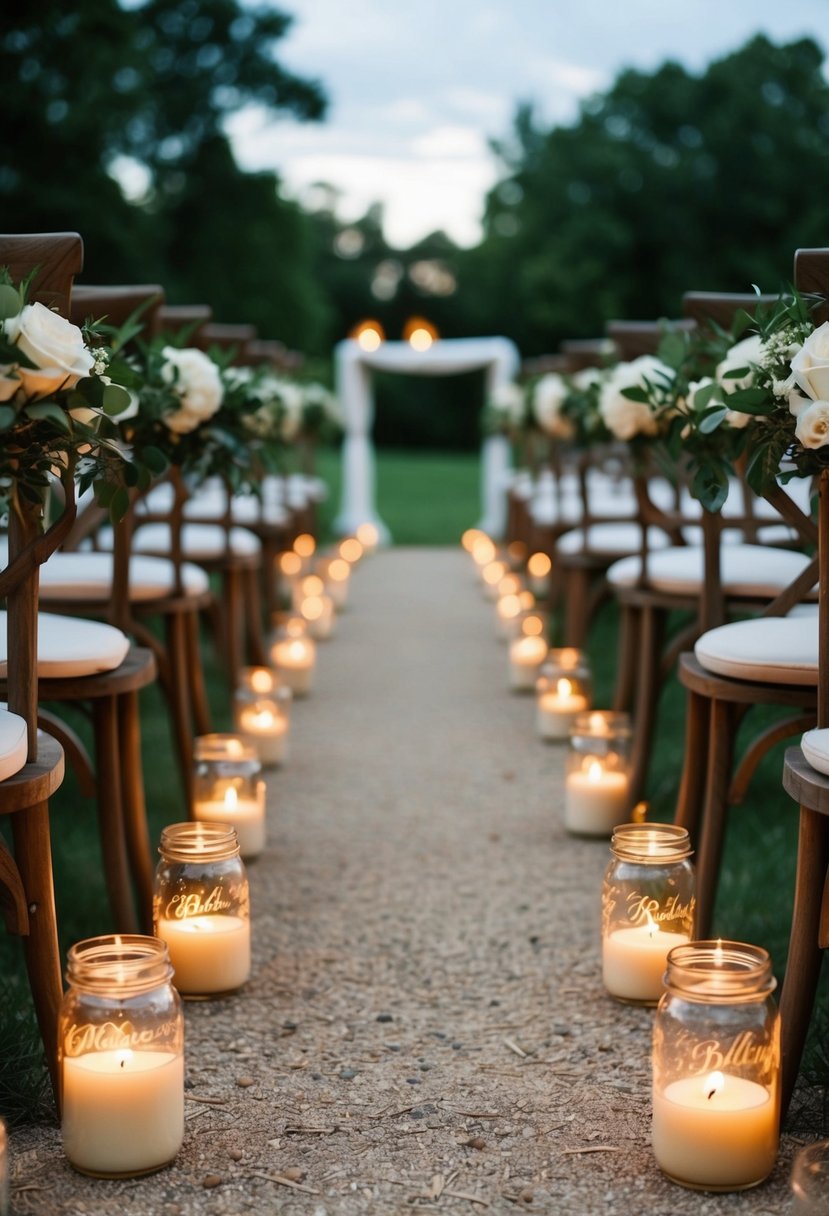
(695, 699), (737, 939)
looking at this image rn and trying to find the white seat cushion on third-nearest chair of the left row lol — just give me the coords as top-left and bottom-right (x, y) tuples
(40, 551), (210, 603)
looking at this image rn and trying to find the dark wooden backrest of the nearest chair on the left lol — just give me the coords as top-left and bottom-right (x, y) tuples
(0, 232), (84, 760)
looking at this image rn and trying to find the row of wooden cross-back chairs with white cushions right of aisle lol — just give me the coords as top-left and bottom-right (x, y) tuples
(509, 249), (829, 1109)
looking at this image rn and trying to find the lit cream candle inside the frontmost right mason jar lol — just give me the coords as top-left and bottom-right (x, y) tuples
(653, 1071), (778, 1190)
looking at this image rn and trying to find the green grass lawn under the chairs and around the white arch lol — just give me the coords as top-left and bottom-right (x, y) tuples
(0, 451), (829, 1120)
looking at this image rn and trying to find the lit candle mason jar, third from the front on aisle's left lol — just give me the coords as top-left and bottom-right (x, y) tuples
(193, 734), (265, 860)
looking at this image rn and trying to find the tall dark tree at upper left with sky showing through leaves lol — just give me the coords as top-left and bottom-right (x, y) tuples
(0, 0), (325, 343)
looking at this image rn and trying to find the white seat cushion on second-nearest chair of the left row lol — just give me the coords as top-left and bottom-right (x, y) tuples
(0, 612), (130, 680)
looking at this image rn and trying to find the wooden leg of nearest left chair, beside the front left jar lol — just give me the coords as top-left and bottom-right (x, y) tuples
(11, 803), (63, 1113)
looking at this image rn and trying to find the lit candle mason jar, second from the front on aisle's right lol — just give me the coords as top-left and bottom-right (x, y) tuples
(602, 823), (697, 1004)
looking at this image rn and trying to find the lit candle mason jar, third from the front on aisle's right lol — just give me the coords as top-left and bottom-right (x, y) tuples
(564, 710), (631, 838)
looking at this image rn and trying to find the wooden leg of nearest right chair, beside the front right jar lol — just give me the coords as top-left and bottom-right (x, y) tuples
(780, 806), (829, 1118)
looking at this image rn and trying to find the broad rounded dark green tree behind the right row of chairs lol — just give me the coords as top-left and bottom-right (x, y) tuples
(461, 36), (829, 354)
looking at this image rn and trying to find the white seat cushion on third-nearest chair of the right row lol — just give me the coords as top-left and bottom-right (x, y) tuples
(608, 545), (810, 598)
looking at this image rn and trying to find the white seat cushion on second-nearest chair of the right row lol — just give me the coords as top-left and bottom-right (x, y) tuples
(694, 613), (818, 687)
